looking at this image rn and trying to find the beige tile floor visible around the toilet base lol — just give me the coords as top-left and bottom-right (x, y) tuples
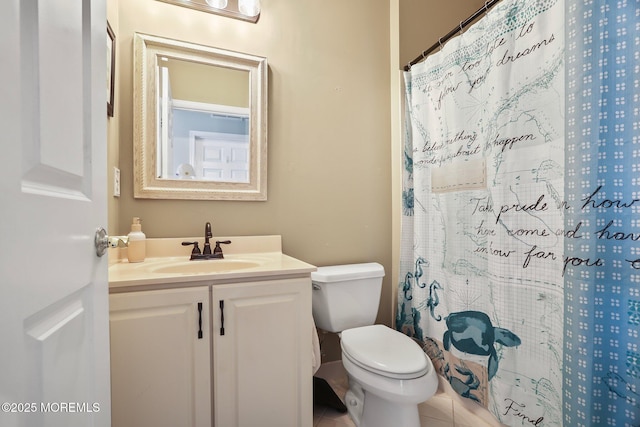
(313, 361), (490, 427)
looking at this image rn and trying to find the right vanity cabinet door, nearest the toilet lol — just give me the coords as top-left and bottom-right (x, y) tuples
(212, 278), (313, 427)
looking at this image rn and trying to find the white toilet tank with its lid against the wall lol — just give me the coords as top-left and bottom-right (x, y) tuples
(311, 262), (384, 332)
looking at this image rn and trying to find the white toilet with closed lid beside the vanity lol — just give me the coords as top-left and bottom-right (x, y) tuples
(311, 263), (438, 427)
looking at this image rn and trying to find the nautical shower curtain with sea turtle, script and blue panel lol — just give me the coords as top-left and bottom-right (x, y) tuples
(396, 0), (640, 427)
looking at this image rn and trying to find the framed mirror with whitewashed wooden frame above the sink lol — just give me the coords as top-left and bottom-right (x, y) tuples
(134, 34), (267, 200)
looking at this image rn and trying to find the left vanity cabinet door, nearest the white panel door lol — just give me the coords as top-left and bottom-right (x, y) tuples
(110, 286), (211, 427)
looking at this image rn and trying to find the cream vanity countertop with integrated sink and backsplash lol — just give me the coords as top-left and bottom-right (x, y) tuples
(109, 236), (316, 293)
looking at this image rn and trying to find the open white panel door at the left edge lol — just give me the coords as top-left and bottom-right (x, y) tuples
(0, 0), (110, 427)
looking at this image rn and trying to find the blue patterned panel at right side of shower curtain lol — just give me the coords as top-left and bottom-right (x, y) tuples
(563, 0), (640, 427)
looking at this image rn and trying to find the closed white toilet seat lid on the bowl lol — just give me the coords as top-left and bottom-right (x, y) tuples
(340, 325), (430, 379)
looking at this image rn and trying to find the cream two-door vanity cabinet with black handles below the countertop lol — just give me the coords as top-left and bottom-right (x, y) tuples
(110, 274), (314, 427)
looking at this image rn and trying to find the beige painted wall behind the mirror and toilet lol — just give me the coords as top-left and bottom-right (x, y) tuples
(107, 0), (484, 359)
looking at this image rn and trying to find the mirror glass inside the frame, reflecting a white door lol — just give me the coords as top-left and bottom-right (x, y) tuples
(157, 56), (250, 183)
